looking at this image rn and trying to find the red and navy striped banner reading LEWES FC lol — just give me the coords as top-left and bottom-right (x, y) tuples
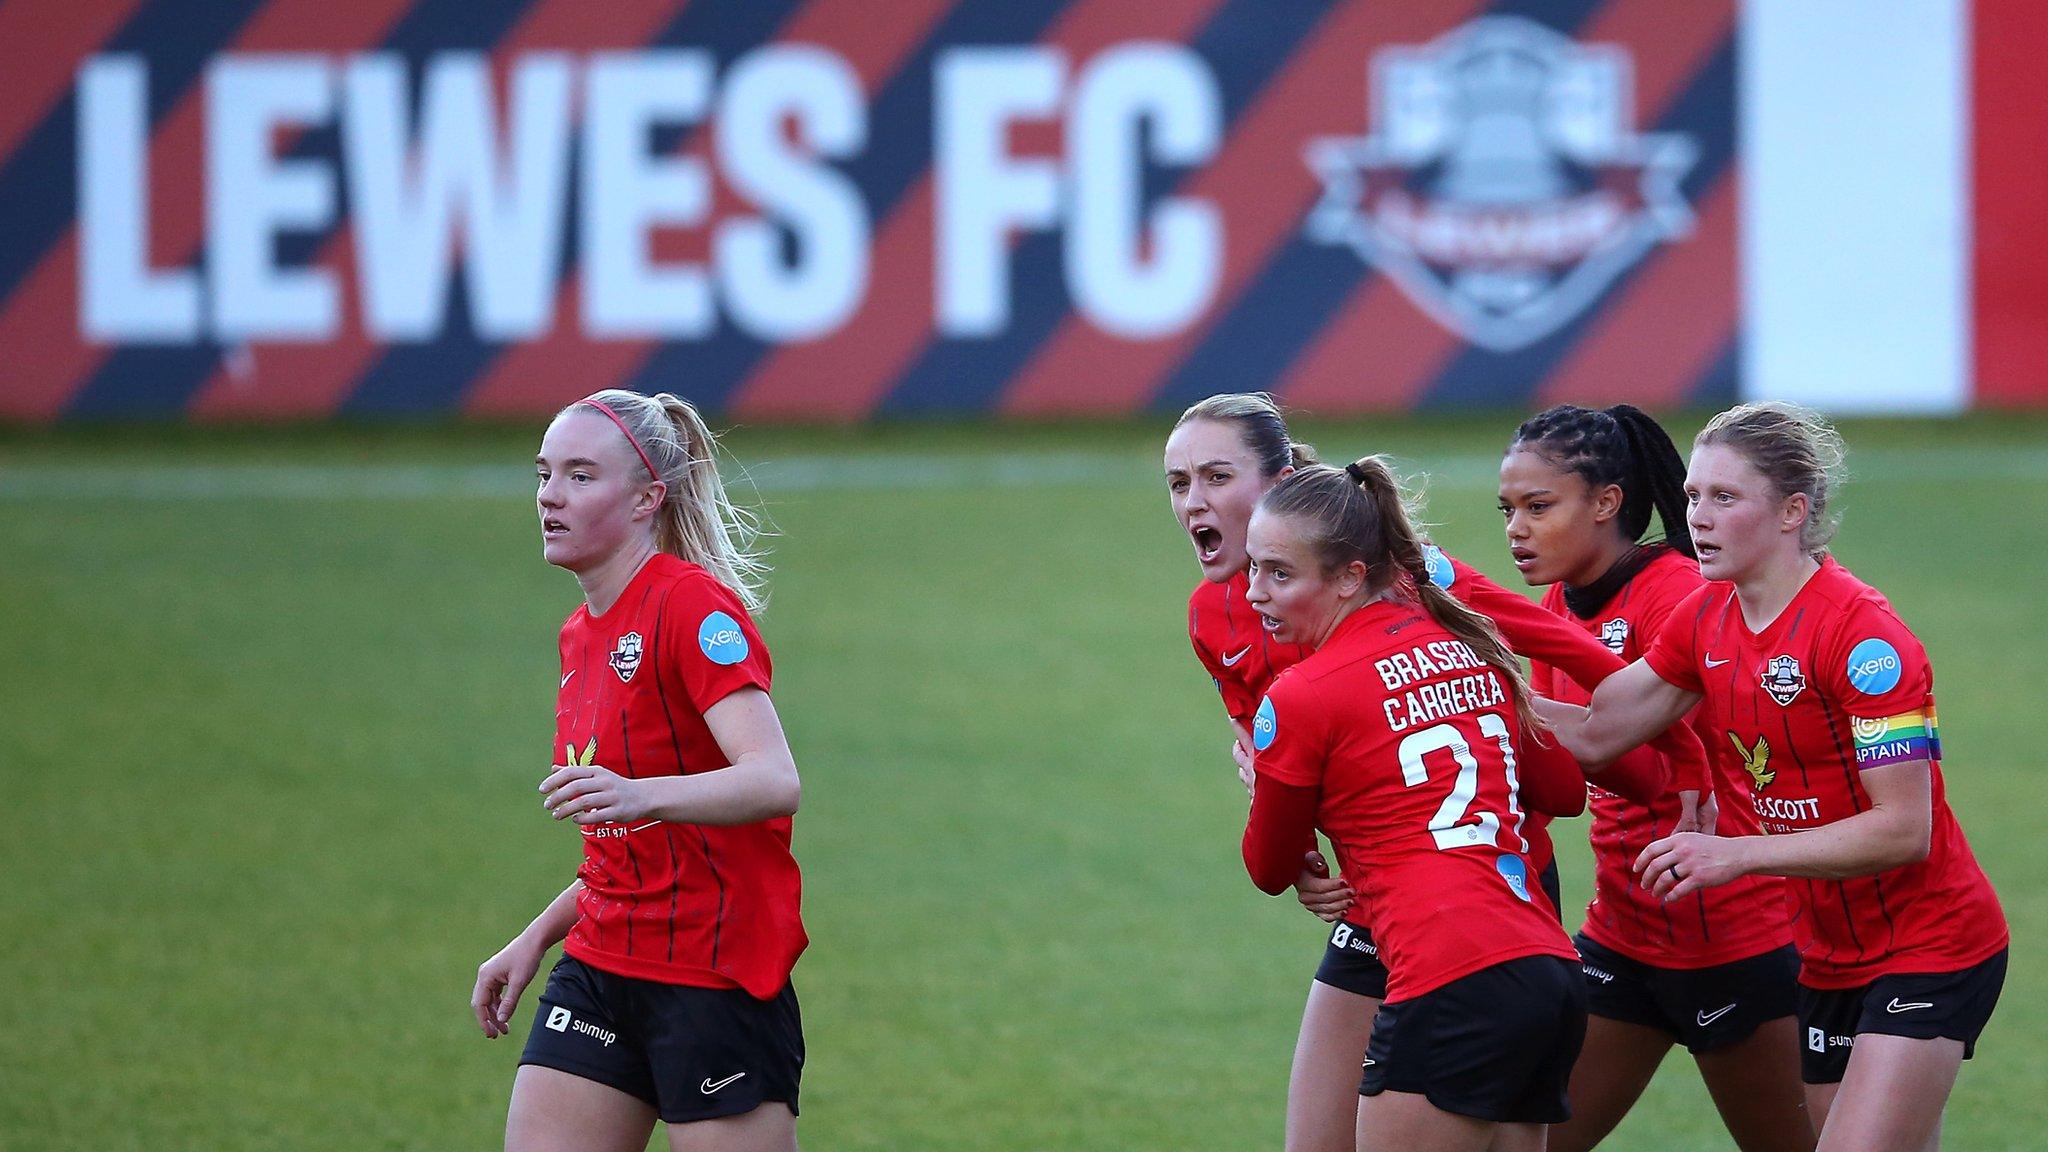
(0, 0), (1741, 422)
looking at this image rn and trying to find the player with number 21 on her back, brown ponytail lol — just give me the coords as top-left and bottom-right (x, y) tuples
(1243, 457), (1585, 1152)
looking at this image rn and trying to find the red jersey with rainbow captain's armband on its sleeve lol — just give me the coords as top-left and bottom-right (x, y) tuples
(1645, 556), (2009, 988)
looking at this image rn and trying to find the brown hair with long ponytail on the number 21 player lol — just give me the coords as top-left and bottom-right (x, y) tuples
(1260, 455), (1542, 730)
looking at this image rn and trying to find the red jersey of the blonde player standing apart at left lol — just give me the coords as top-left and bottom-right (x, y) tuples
(553, 553), (807, 1000)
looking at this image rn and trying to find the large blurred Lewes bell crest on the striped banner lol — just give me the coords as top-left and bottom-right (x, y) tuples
(1307, 16), (1700, 351)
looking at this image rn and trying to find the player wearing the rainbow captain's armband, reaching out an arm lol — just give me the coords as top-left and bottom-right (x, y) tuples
(1546, 404), (2009, 1152)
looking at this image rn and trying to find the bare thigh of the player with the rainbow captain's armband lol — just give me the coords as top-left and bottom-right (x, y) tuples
(1821, 1031), (1962, 1152)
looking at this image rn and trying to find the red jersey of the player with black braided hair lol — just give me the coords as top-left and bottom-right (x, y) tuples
(1532, 549), (1792, 968)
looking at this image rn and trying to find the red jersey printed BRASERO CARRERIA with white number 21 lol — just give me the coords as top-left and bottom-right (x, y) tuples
(1251, 601), (1579, 1000)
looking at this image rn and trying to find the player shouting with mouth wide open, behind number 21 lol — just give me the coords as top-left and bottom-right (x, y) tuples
(1165, 394), (1704, 1152)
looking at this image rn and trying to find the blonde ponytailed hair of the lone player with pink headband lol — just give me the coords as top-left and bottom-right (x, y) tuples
(571, 387), (768, 611)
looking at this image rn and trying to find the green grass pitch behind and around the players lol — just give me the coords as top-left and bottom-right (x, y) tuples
(0, 416), (2048, 1152)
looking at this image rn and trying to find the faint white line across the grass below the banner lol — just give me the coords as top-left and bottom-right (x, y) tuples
(0, 445), (2048, 502)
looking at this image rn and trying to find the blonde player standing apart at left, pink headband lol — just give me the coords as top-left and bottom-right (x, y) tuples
(471, 389), (805, 1152)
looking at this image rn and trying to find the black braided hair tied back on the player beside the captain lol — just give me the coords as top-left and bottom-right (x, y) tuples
(1507, 404), (1694, 556)
